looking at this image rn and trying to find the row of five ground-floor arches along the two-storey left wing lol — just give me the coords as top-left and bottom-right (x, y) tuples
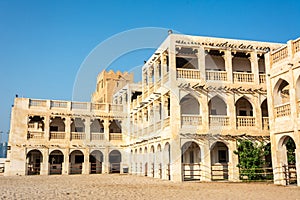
(26, 149), (122, 175)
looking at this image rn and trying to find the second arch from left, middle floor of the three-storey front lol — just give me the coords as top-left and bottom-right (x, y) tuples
(208, 96), (229, 127)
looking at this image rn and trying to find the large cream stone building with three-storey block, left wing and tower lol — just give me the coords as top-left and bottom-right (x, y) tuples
(6, 34), (290, 181)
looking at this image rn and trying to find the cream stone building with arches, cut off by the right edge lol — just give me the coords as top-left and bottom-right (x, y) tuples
(267, 38), (300, 185)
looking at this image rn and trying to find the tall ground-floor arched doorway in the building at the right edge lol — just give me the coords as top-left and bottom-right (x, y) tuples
(281, 136), (297, 185)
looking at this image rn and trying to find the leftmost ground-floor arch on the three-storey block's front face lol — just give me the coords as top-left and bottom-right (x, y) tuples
(181, 142), (201, 181)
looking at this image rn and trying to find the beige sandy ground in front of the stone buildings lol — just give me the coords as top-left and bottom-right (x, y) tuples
(0, 174), (300, 200)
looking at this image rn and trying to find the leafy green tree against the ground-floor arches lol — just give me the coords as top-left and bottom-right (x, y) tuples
(234, 139), (270, 180)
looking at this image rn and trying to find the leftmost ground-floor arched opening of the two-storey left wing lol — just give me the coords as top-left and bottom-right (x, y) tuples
(26, 149), (43, 175)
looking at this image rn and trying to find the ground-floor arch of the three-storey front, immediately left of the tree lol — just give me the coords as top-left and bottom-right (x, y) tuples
(211, 142), (229, 180)
